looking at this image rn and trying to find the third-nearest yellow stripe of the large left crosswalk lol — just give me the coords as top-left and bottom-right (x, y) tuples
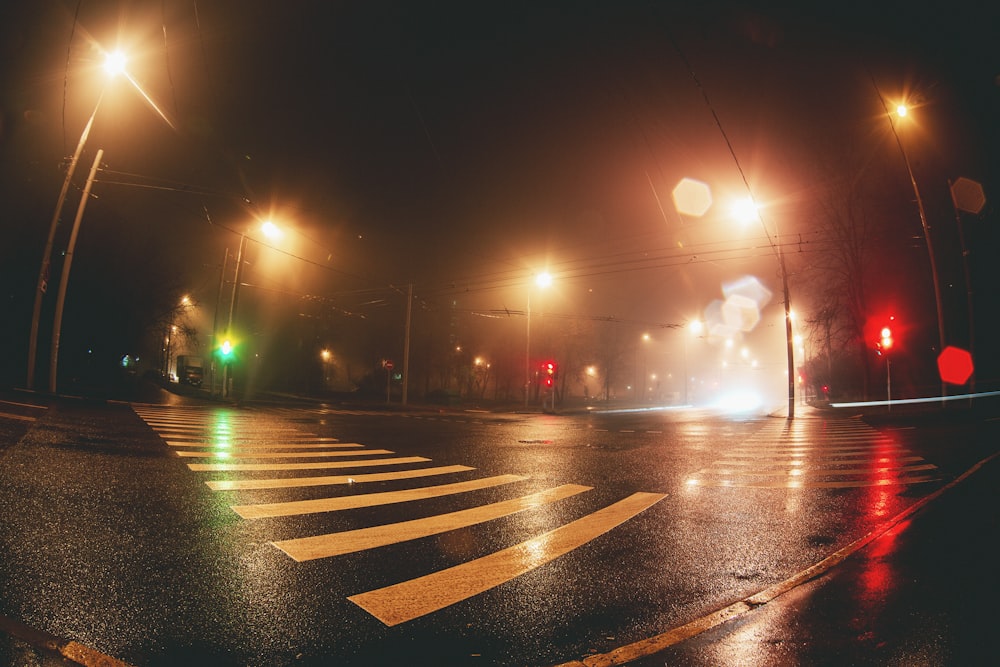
(230, 475), (528, 519)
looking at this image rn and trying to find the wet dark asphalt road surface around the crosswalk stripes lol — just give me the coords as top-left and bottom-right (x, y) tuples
(0, 388), (998, 665)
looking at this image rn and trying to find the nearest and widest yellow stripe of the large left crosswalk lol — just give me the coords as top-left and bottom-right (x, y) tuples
(347, 493), (665, 626)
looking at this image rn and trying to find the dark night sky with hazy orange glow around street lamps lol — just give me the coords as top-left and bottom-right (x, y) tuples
(0, 0), (1000, 394)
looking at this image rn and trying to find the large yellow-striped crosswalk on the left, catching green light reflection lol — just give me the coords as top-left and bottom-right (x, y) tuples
(132, 404), (665, 626)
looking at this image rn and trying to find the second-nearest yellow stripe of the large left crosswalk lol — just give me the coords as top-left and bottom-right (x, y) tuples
(271, 484), (591, 563)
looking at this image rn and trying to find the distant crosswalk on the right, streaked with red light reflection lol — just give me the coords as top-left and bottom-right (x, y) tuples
(687, 419), (941, 488)
